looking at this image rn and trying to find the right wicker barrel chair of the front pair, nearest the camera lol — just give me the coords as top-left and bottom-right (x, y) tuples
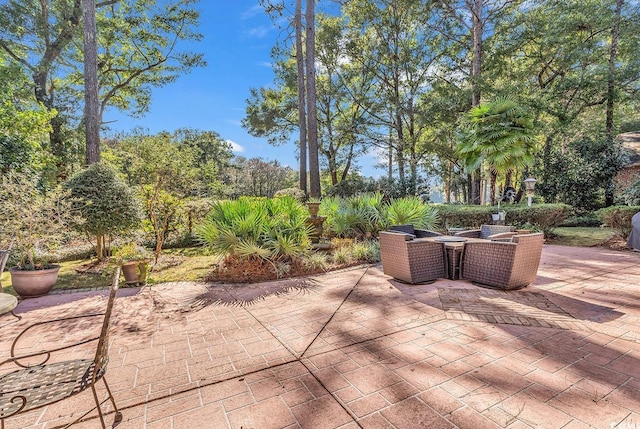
(460, 233), (544, 290)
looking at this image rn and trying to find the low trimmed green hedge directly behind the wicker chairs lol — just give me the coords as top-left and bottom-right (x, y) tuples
(437, 204), (572, 235)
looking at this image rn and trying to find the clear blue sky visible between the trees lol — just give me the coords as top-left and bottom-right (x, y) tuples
(104, 0), (380, 175)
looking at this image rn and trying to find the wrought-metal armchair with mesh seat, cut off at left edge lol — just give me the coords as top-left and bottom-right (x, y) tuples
(0, 268), (122, 429)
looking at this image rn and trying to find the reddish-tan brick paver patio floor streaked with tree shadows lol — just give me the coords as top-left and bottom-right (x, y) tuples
(0, 242), (640, 429)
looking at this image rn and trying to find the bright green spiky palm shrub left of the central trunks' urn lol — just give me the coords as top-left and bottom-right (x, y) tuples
(196, 196), (311, 267)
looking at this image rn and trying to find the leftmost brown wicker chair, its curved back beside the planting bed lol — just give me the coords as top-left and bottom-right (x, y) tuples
(379, 231), (447, 284)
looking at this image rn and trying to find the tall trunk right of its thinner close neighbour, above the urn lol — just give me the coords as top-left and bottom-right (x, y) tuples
(305, 0), (321, 198)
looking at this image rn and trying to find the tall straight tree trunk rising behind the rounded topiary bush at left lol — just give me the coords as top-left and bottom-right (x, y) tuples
(82, 0), (100, 165)
